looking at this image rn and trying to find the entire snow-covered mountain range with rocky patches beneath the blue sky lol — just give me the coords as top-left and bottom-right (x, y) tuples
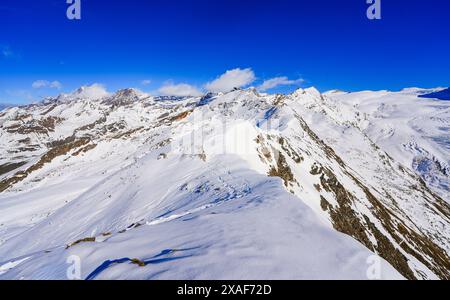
(0, 88), (450, 279)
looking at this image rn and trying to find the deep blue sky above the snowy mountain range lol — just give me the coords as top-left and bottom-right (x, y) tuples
(0, 0), (450, 103)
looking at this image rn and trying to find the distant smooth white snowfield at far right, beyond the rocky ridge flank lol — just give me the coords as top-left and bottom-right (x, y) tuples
(328, 88), (450, 201)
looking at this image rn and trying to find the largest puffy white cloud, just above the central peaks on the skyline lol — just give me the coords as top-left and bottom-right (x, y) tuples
(205, 68), (256, 93)
